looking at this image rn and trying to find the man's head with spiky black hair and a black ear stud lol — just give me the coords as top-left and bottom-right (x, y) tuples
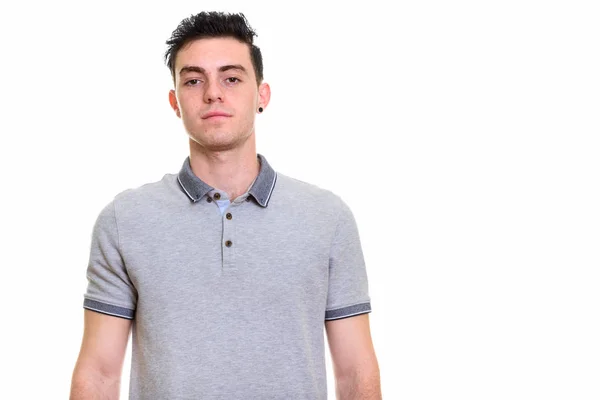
(165, 12), (270, 151)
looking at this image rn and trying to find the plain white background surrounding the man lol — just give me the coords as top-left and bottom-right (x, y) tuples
(0, 1), (600, 400)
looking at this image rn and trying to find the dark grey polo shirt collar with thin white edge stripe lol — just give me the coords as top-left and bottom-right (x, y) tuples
(177, 154), (277, 207)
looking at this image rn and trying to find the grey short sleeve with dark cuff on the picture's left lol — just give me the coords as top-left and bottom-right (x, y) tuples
(83, 200), (137, 319)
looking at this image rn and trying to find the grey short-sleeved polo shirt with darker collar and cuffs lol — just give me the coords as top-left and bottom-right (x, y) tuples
(84, 154), (371, 400)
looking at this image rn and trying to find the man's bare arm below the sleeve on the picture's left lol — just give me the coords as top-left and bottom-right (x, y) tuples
(70, 309), (131, 400)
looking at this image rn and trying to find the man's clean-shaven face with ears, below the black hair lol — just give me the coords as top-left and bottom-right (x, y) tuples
(169, 38), (269, 151)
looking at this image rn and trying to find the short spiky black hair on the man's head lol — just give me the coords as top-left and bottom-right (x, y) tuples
(165, 11), (263, 84)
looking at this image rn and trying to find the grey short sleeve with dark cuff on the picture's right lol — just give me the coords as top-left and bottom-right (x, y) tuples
(325, 199), (371, 321)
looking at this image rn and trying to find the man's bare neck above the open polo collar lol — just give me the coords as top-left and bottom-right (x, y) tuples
(190, 143), (260, 201)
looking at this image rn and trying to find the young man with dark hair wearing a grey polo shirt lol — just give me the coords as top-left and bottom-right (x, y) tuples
(71, 12), (381, 400)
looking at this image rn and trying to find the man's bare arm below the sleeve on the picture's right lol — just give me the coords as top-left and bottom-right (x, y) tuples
(325, 314), (381, 400)
